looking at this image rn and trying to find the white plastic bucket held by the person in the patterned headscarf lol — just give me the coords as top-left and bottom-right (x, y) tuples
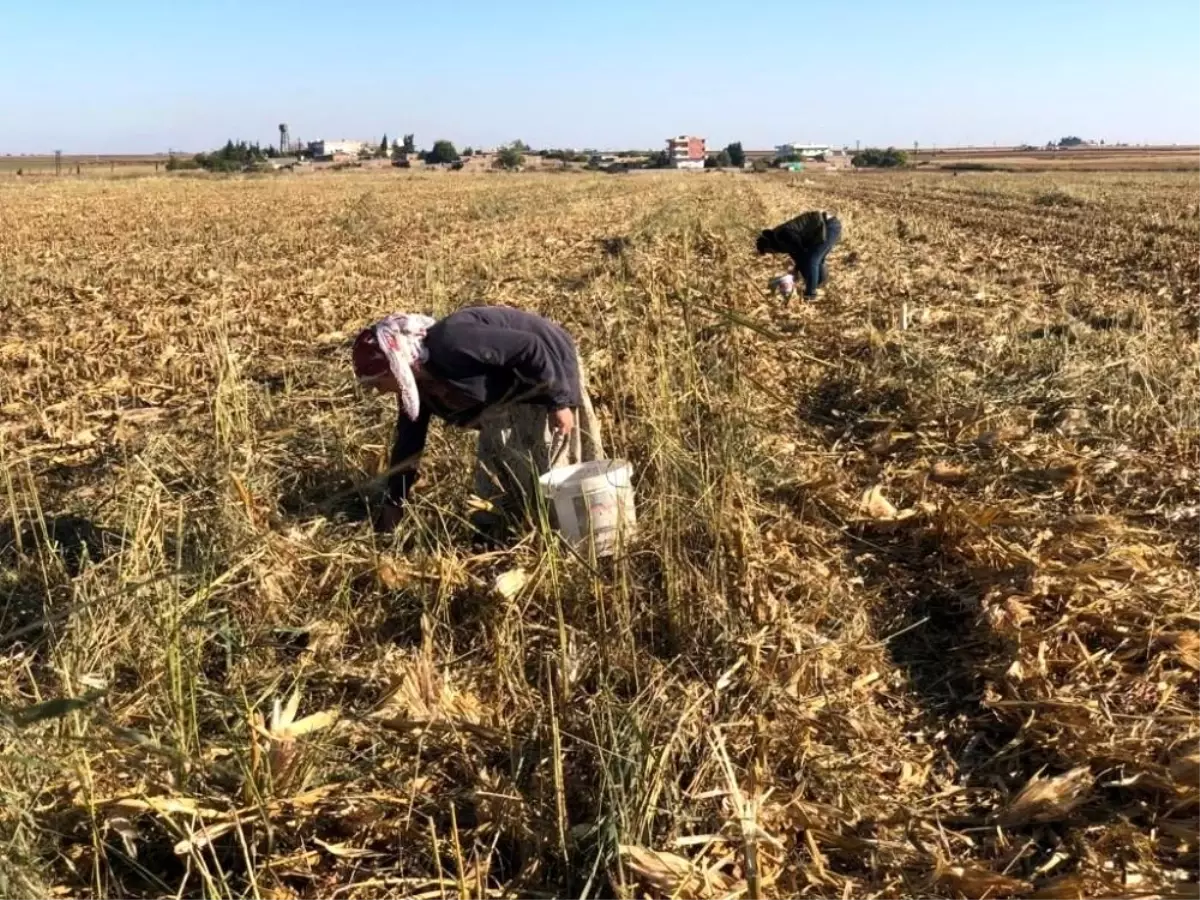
(538, 460), (637, 557)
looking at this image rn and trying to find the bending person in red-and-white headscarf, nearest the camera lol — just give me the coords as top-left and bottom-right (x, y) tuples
(353, 306), (604, 536)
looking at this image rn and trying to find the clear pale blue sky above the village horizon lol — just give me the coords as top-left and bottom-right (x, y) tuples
(0, 0), (1200, 154)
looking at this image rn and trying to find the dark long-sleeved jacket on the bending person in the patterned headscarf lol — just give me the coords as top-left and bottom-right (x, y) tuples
(388, 306), (581, 503)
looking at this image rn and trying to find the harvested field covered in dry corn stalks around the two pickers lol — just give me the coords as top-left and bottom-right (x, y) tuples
(0, 172), (1200, 900)
